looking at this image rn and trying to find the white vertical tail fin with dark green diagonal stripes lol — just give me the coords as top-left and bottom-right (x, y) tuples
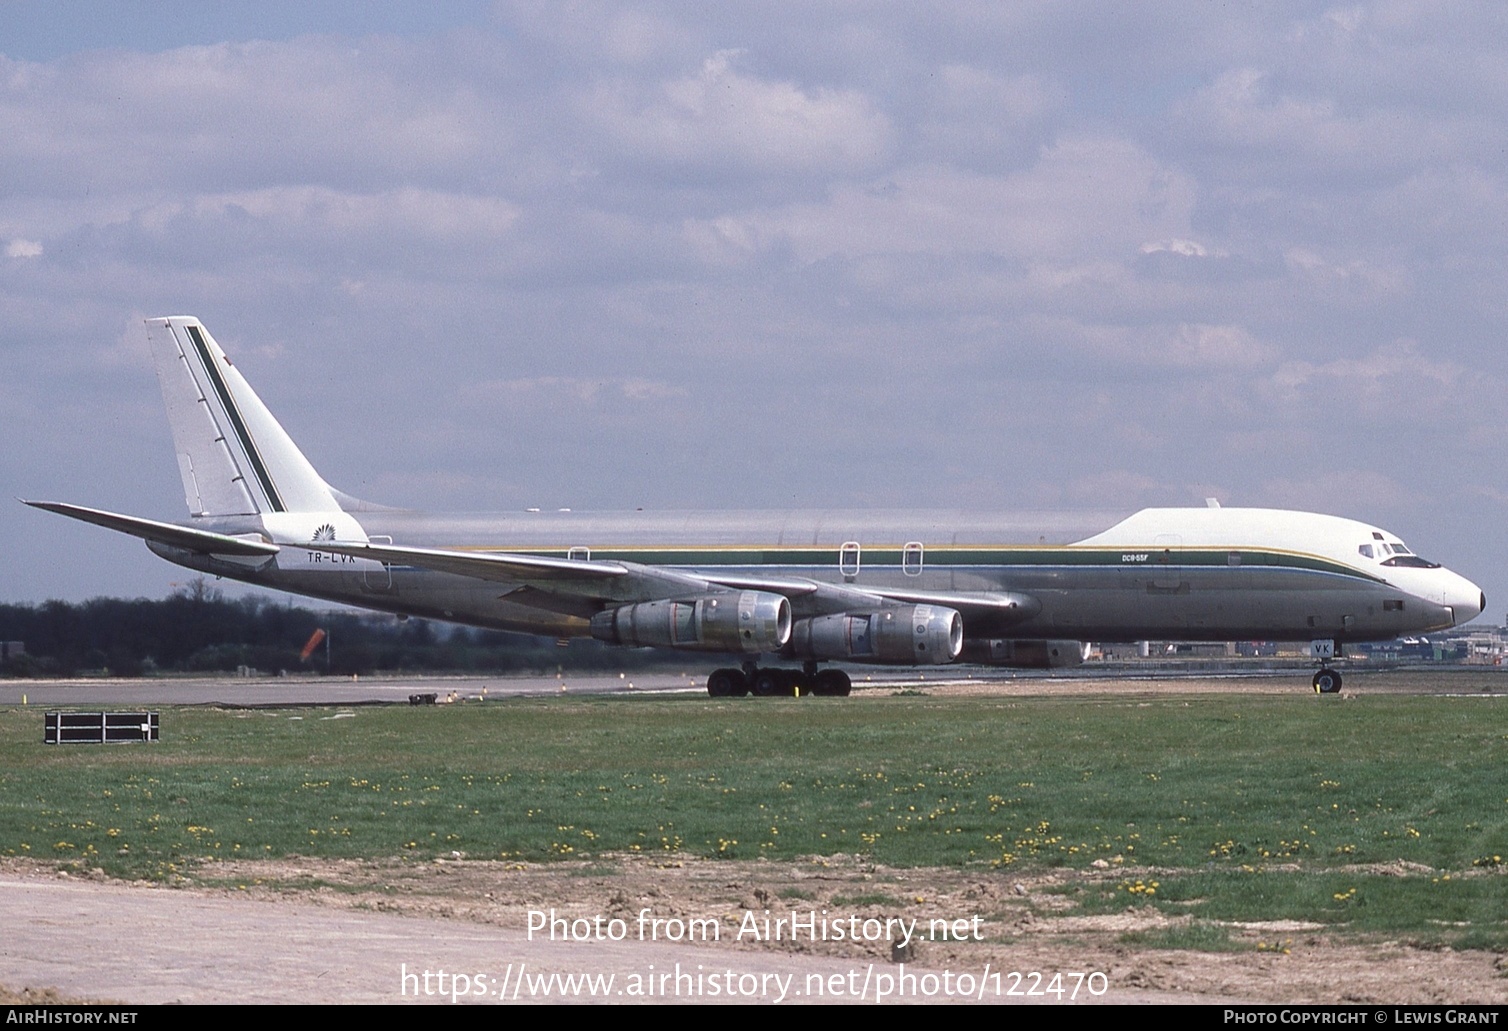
(146, 315), (341, 516)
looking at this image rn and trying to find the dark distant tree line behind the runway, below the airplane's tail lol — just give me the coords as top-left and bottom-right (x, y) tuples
(0, 580), (685, 677)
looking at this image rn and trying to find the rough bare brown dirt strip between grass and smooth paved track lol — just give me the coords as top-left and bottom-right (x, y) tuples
(0, 856), (1508, 1005)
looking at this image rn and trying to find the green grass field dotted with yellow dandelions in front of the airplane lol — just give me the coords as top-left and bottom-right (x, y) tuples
(0, 695), (1508, 948)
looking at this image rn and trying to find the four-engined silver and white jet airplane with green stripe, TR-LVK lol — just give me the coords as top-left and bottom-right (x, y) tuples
(26, 315), (1487, 698)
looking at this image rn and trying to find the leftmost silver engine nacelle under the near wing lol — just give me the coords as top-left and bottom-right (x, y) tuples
(591, 591), (790, 654)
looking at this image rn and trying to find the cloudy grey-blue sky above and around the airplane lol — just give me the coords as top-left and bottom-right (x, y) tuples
(0, 0), (1508, 621)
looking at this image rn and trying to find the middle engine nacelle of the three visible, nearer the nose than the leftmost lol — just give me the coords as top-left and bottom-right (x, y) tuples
(789, 604), (964, 666)
